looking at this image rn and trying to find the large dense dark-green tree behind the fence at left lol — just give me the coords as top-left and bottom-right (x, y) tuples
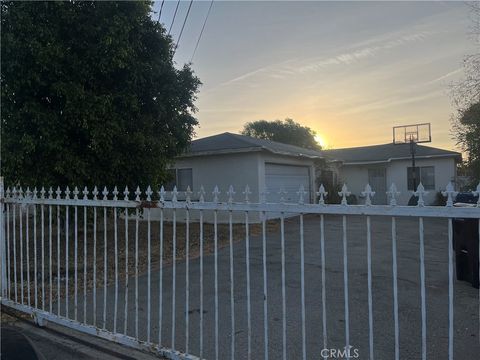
(1, 1), (200, 188)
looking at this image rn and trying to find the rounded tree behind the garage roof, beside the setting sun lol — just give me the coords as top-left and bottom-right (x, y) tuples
(242, 118), (321, 150)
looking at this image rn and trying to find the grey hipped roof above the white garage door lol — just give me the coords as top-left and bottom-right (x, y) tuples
(181, 132), (323, 158)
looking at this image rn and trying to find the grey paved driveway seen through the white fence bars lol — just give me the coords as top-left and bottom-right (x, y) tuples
(70, 215), (480, 359)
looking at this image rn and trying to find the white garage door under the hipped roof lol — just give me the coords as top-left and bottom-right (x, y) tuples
(265, 163), (310, 203)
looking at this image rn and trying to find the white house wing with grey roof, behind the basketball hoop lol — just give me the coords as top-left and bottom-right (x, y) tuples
(322, 144), (462, 205)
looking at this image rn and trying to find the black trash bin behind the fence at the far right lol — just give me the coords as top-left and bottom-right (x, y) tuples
(453, 193), (479, 289)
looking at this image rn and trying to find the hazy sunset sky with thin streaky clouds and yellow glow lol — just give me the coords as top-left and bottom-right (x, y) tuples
(153, 0), (478, 149)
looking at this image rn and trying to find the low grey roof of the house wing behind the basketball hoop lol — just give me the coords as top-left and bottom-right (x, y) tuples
(323, 143), (462, 165)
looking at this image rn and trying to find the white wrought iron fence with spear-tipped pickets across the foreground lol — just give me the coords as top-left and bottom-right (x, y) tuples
(0, 178), (480, 360)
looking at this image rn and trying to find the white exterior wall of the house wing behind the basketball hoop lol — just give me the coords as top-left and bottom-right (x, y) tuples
(339, 158), (456, 205)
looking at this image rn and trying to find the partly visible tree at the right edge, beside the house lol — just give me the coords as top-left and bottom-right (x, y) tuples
(453, 102), (480, 186)
